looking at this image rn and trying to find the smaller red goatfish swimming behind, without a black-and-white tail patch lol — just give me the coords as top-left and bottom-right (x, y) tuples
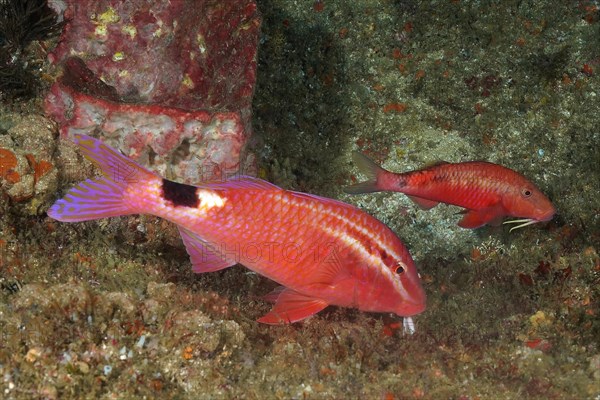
(344, 152), (556, 231)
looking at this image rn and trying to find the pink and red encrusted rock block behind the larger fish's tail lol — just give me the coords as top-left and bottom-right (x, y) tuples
(45, 0), (260, 183)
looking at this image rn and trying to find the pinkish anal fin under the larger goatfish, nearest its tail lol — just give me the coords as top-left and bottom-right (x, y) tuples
(177, 226), (236, 274)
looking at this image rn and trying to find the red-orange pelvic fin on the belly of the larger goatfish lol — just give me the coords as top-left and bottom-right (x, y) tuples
(258, 288), (328, 325)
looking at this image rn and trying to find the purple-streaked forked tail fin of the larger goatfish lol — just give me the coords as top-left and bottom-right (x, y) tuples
(47, 134), (156, 222)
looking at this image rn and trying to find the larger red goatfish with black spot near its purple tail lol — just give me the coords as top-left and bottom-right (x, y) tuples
(48, 135), (425, 327)
